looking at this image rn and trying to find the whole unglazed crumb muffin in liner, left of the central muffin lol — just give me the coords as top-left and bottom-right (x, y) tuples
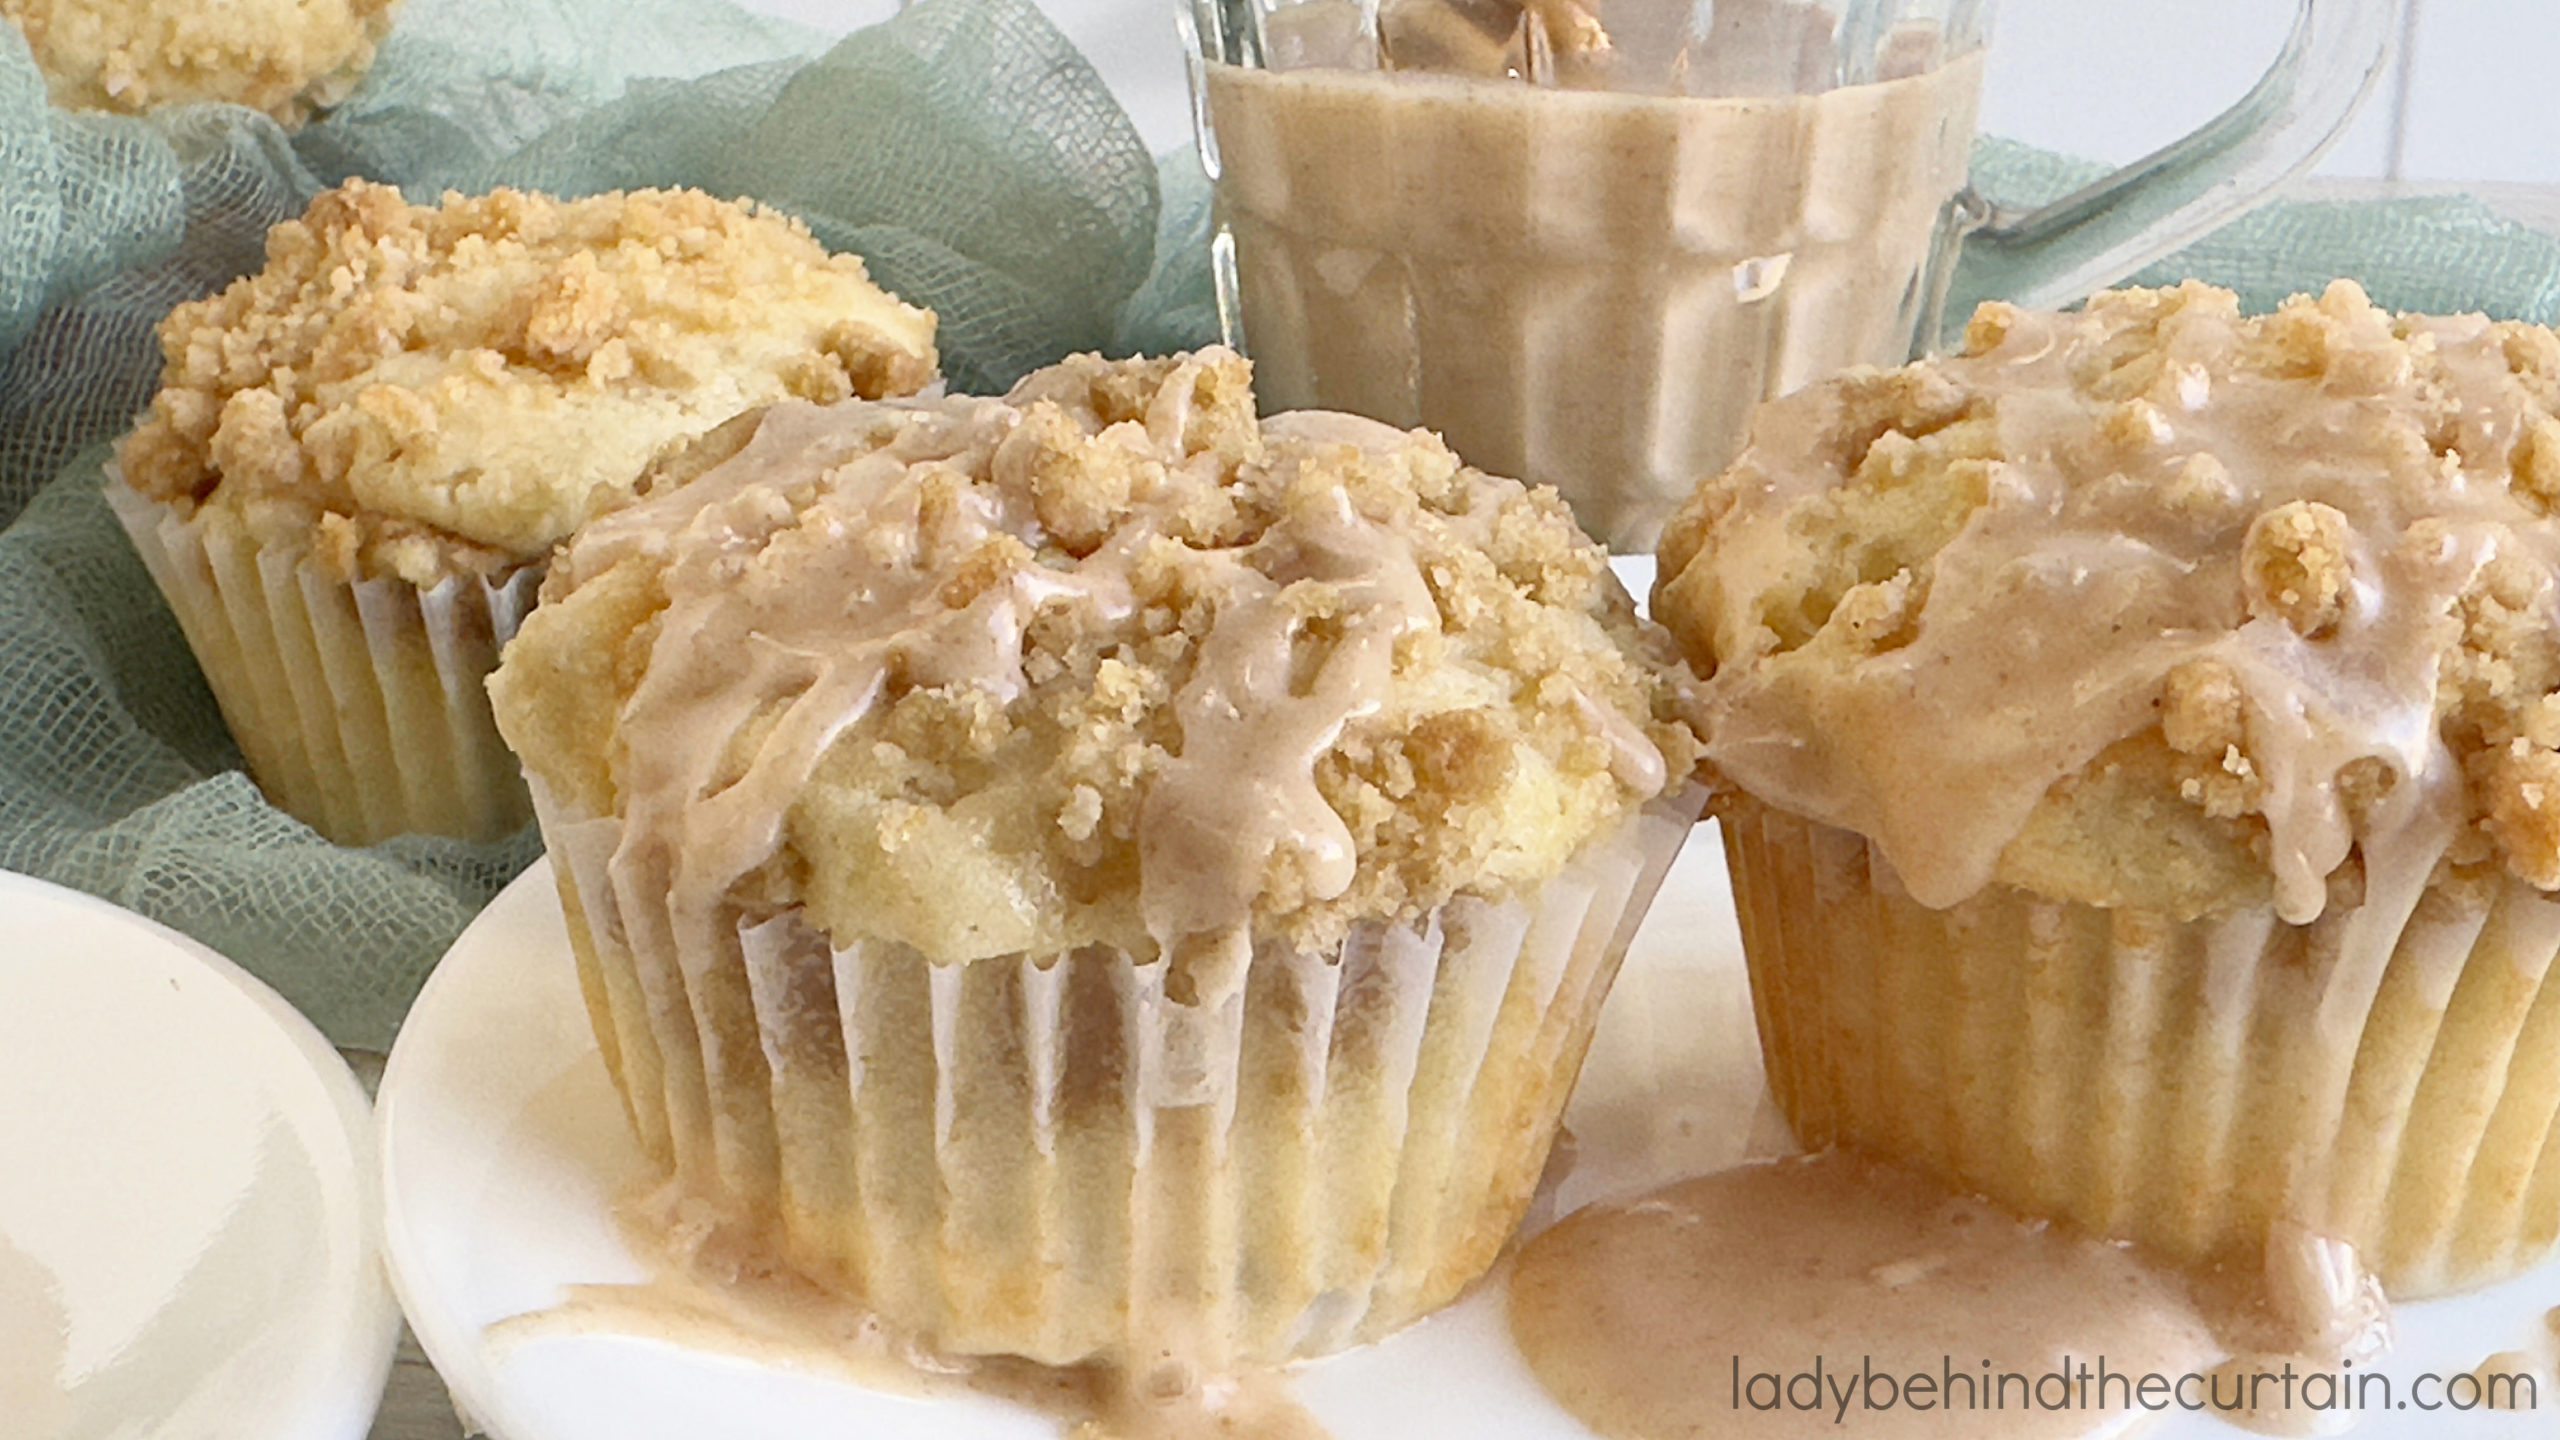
(108, 182), (934, 843)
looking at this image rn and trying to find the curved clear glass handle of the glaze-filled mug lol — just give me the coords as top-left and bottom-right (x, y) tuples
(1920, 0), (2409, 330)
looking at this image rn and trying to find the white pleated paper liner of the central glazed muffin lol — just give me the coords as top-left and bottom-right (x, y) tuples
(535, 787), (1702, 1366)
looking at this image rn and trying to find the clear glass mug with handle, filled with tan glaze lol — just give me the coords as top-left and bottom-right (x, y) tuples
(1183, 0), (2406, 551)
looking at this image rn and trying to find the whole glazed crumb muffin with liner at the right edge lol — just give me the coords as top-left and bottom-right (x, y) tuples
(1654, 282), (2560, 1297)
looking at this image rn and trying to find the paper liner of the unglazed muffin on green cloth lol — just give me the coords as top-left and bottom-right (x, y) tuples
(108, 479), (543, 846)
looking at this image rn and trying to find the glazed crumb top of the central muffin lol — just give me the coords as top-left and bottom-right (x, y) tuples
(492, 348), (1695, 963)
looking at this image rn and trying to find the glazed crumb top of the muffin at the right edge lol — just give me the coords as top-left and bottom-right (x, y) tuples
(1654, 282), (2560, 922)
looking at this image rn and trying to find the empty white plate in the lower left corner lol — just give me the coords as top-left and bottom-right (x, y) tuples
(0, 874), (399, 1440)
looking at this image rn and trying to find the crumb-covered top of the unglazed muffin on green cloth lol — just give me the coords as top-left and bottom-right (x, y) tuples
(118, 179), (934, 584)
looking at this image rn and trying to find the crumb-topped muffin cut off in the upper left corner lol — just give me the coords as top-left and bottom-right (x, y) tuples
(0, 0), (399, 126)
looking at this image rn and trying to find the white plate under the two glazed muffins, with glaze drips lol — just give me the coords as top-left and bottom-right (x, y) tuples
(381, 830), (2560, 1440)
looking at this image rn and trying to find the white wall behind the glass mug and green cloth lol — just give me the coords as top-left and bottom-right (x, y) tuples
(740, 0), (2560, 184)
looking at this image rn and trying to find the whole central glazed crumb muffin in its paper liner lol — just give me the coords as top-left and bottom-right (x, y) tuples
(492, 348), (1702, 1376)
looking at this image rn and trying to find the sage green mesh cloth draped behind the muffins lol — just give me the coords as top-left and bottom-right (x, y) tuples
(0, 0), (2560, 1048)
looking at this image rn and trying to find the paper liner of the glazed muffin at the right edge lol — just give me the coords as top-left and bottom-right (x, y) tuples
(1723, 802), (2560, 1297)
